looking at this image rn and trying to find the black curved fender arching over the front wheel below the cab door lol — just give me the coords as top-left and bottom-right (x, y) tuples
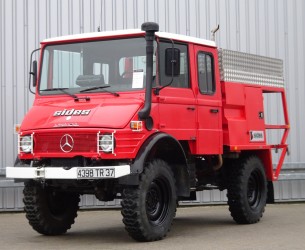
(131, 133), (190, 197)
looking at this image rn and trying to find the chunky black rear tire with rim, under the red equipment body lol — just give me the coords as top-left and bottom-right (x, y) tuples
(227, 156), (267, 224)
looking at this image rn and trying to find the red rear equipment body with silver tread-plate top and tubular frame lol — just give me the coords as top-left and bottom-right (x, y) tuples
(218, 49), (290, 180)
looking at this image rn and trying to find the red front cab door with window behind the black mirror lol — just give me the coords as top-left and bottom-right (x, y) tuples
(157, 41), (197, 141)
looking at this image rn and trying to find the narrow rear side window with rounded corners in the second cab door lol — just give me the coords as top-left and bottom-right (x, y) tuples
(197, 52), (215, 95)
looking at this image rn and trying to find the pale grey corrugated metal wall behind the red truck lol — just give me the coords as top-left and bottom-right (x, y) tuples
(0, 0), (305, 203)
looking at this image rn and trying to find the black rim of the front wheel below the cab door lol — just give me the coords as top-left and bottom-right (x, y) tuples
(146, 178), (171, 226)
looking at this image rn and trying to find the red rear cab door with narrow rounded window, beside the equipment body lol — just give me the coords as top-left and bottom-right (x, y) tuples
(193, 45), (223, 155)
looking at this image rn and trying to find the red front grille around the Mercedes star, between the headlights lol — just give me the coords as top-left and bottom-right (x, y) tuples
(34, 133), (97, 153)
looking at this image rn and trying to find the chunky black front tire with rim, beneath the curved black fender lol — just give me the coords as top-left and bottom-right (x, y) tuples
(121, 160), (177, 241)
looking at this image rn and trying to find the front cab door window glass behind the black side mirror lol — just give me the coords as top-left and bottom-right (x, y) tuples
(159, 42), (189, 88)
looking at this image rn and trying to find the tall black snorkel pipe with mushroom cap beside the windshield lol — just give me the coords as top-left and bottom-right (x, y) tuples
(138, 22), (159, 120)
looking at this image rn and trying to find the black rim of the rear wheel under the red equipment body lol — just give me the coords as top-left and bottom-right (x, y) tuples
(247, 170), (264, 209)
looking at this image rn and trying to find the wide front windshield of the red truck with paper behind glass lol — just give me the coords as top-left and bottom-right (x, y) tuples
(39, 37), (156, 95)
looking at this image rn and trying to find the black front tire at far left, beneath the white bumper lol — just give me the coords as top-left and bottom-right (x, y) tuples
(23, 181), (80, 235)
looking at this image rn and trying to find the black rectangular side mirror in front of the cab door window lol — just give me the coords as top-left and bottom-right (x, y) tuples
(165, 48), (180, 76)
